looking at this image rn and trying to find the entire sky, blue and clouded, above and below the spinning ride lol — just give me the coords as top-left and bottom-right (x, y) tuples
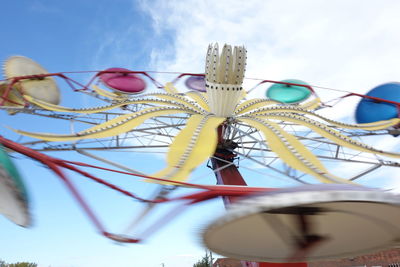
(0, 0), (400, 267)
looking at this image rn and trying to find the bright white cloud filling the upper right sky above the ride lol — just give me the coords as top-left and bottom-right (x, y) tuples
(142, 0), (400, 191)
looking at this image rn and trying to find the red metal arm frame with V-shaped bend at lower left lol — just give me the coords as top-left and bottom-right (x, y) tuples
(0, 135), (276, 243)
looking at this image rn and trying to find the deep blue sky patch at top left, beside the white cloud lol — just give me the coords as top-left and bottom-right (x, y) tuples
(1, 0), (162, 70)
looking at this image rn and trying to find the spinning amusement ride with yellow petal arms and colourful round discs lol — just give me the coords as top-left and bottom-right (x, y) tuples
(0, 44), (400, 262)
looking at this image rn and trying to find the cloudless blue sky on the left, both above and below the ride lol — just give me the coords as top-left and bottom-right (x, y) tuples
(0, 0), (211, 267)
